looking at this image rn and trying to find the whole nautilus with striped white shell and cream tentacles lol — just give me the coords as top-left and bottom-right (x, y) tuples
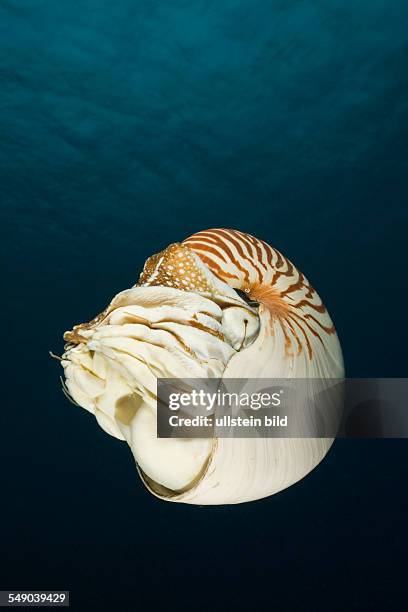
(62, 229), (344, 505)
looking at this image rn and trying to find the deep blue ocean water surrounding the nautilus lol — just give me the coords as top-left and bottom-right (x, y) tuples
(0, 0), (408, 612)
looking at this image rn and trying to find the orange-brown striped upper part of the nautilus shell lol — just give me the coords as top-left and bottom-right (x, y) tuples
(183, 229), (343, 377)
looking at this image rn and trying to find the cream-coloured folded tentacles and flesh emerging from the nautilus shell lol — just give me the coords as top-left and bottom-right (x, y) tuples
(63, 280), (259, 491)
